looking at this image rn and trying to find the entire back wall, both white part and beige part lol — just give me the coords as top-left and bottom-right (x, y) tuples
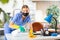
(0, 0), (60, 22)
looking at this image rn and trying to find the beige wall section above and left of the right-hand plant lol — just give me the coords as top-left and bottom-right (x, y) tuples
(32, 1), (60, 21)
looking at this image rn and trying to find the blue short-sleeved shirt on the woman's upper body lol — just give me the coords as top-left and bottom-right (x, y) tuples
(11, 12), (31, 26)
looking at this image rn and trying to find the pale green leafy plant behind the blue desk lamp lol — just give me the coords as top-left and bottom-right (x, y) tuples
(47, 5), (60, 28)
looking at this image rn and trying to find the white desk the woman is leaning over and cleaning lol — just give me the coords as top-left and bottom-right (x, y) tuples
(6, 33), (60, 40)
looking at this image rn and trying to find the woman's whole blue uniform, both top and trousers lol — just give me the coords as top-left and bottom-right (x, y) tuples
(4, 13), (31, 40)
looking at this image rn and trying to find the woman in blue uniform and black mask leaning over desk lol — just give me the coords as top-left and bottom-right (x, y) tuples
(4, 5), (30, 40)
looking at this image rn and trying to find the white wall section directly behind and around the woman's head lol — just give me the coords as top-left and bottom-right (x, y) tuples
(0, 0), (36, 20)
